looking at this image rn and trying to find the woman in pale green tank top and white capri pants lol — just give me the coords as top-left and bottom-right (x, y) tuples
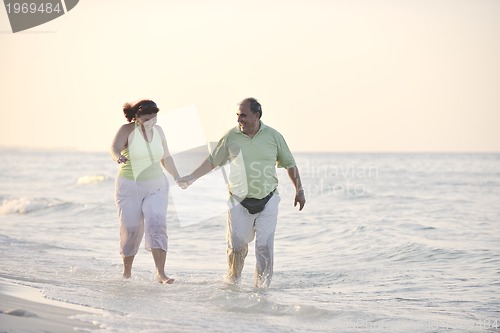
(111, 100), (179, 284)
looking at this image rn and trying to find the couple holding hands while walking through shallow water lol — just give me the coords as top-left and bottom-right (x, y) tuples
(111, 98), (306, 288)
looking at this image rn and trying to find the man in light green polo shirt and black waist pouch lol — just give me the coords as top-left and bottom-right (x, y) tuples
(177, 98), (306, 288)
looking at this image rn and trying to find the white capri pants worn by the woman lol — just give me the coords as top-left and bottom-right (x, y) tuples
(115, 177), (169, 257)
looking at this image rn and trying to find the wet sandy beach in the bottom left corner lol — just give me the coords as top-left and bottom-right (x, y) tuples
(0, 280), (102, 333)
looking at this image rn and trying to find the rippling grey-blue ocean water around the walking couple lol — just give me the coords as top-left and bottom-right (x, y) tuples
(0, 148), (500, 333)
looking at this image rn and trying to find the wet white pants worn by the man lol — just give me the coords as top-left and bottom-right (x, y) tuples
(227, 192), (281, 288)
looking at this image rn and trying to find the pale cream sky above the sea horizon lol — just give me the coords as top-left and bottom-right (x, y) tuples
(0, 0), (500, 152)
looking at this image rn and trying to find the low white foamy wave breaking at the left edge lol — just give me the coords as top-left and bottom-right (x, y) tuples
(0, 197), (72, 215)
